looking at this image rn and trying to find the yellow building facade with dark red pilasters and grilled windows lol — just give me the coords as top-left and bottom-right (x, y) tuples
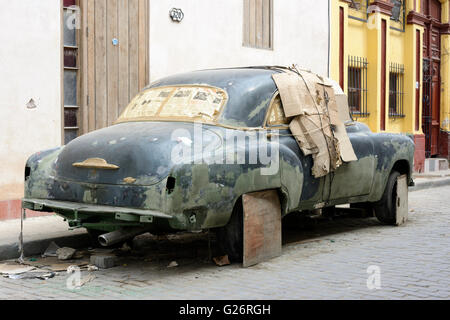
(330, 0), (450, 171)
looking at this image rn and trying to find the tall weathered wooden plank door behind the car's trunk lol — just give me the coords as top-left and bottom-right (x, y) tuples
(82, 0), (149, 133)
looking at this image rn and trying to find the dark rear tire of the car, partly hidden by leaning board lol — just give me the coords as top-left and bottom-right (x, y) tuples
(216, 198), (244, 262)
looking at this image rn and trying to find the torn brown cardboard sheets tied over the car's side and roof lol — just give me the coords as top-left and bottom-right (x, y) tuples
(273, 71), (357, 178)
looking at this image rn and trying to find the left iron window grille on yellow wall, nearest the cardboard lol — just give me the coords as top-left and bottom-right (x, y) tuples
(348, 56), (370, 117)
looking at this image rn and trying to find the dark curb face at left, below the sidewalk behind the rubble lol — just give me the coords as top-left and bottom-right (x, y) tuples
(0, 233), (90, 261)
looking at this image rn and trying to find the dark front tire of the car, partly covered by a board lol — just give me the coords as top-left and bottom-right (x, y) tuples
(374, 171), (400, 225)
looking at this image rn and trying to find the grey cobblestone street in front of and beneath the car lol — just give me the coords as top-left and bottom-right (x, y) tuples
(0, 187), (450, 299)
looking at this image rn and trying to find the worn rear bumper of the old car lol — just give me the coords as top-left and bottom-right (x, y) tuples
(22, 198), (173, 223)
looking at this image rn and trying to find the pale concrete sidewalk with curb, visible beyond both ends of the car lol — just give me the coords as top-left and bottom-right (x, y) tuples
(0, 172), (450, 261)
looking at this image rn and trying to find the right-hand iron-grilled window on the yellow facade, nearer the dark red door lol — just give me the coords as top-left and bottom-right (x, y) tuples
(389, 63), (405, 118)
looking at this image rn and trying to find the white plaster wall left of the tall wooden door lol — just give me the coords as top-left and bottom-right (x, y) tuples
(0, 0), (61, 201)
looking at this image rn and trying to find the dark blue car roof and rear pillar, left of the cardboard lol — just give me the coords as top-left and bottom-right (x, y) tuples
(148, 66), (282, 127)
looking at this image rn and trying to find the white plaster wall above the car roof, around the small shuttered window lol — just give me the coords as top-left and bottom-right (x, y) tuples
(150, 0), (328, 81)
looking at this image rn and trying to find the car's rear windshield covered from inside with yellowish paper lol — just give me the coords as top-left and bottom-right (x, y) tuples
(117, 86), (228, 123)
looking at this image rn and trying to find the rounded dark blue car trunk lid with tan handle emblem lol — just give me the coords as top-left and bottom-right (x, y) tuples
(55, 122), (219, 186)
